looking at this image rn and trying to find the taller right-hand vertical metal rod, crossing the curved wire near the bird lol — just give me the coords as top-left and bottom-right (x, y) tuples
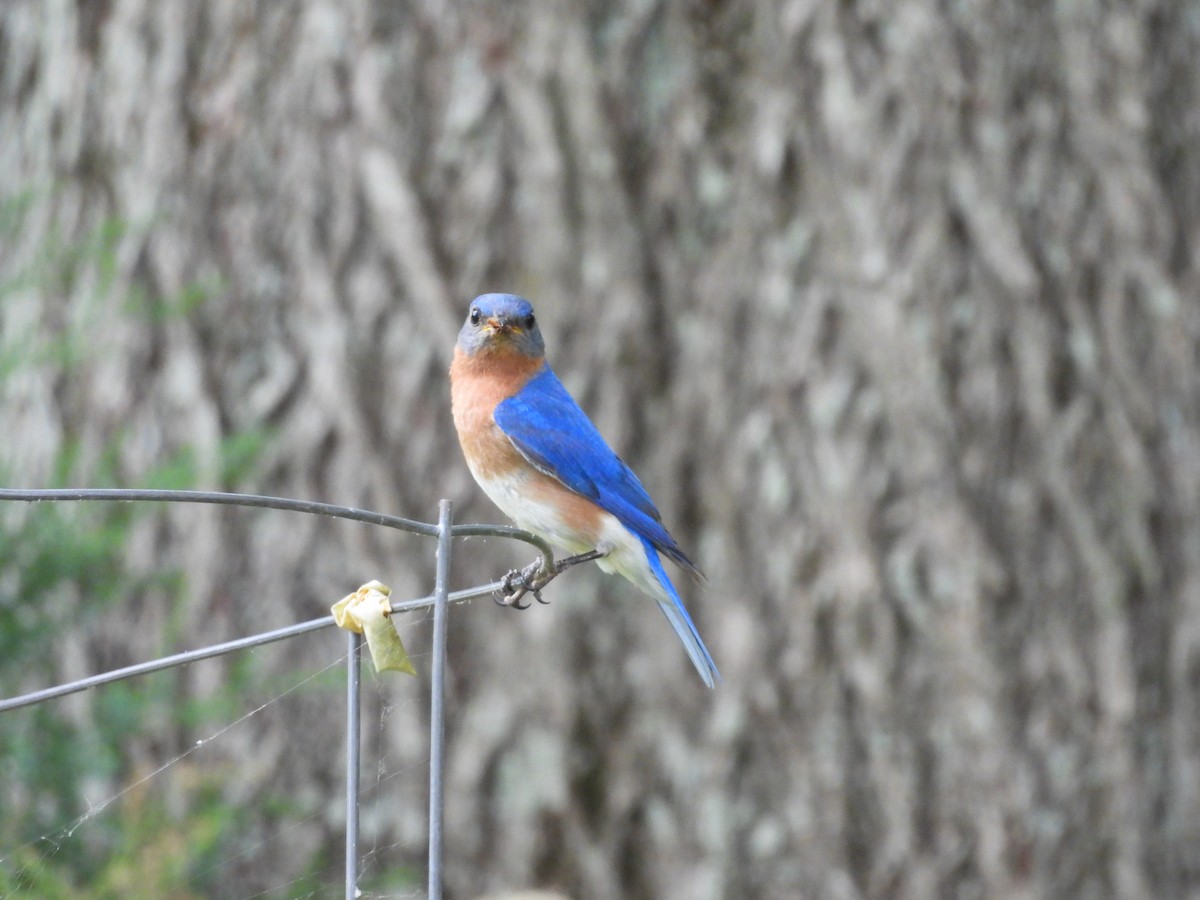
(427, 500), (452, 900)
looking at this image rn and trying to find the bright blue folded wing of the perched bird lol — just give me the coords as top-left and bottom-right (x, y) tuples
(493, 366), (696, 571)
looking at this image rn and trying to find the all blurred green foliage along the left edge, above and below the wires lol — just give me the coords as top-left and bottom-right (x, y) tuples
(0, 191), (290, 900)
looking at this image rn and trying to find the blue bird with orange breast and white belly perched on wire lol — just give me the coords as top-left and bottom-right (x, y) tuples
(450, 294), (721, 688)
